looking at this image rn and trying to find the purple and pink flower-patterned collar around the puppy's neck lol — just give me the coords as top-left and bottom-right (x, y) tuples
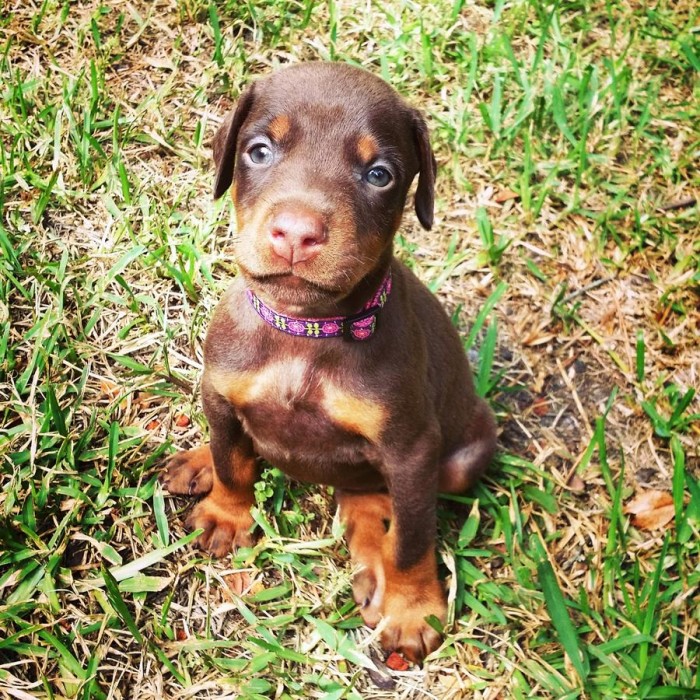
(246, 271), (391, 340)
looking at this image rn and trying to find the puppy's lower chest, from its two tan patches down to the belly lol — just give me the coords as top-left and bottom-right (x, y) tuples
(214, 358), (386, 454)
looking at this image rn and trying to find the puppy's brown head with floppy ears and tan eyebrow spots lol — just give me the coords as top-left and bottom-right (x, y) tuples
(213, 63), (435, 313)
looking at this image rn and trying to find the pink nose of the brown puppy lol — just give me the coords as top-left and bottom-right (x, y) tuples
(270, 205), (328, 265)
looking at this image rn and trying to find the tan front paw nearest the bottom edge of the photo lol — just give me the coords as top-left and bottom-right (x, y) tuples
(381, 590), (447, 664)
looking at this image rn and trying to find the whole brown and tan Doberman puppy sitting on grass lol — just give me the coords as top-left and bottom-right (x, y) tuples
(163, 63), (495, 661)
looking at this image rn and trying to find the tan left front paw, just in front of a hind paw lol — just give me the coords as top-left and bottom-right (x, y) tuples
(185, 496), (255, 557)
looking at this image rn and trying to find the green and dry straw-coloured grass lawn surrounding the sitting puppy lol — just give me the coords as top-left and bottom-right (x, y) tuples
(0, 0), (700, 700)
